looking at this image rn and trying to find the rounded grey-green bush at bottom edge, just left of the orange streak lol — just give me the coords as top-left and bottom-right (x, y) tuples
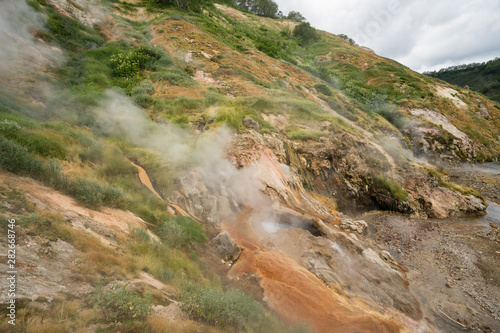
(181, 283), (270, 332)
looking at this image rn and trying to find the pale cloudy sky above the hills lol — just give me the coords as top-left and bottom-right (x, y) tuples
(274, 0), (500, 72)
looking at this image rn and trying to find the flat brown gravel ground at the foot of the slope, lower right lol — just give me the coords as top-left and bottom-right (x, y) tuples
(363, 165), (500, 332)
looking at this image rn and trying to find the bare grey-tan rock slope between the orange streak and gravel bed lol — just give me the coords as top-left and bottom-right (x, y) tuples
(272, 223), (422, 320)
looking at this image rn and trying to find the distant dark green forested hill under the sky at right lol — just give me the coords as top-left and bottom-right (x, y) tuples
(424, 58), (500, 103)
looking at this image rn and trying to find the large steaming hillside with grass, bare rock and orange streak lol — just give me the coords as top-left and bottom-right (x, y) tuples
(0, 0), (500, 332)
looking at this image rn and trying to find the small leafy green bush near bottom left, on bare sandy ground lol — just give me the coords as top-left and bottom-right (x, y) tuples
(90, 281), (152, 322)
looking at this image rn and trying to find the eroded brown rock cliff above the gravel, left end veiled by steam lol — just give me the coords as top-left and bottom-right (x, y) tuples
(169, 124), (486, 231)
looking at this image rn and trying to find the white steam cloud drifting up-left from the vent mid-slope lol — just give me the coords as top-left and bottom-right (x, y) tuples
(96, 90), (270, 220)
